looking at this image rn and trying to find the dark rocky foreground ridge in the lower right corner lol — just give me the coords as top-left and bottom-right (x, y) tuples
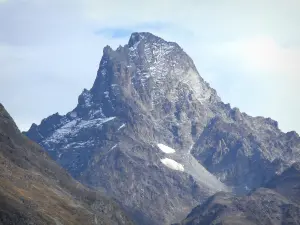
(180, 164), (300, 225)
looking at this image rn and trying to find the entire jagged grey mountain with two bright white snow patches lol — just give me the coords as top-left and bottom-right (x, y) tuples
(25, 33), (300, 225)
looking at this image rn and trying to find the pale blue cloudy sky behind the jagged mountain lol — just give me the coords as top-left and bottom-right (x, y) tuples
(0, 0), (300, 133)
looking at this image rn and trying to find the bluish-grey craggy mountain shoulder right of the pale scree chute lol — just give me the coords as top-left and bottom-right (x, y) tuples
(192, 109), (300, 193)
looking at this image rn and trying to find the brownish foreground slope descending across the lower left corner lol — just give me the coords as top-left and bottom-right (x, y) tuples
(0, 104), (133, 225)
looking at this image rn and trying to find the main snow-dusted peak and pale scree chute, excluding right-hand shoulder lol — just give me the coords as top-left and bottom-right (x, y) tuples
(26, 33), (227, 224)
